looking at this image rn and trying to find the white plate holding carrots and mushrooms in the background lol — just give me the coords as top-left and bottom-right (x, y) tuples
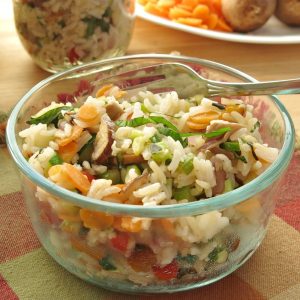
(136, 3), (300, 44)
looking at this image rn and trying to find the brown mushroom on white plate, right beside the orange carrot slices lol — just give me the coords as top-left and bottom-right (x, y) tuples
(222, 0), (276, 32)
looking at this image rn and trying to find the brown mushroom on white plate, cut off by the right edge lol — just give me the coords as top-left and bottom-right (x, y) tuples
(275, 0), (300, 26)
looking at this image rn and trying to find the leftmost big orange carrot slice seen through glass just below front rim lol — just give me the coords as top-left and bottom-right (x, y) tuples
(79, 208), (114, 230)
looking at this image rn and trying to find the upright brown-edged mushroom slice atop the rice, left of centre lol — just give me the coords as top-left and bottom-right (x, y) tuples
(92, 114), (114, 163)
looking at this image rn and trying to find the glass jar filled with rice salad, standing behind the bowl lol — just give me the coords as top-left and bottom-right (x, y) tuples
(13, 0), (135, 73)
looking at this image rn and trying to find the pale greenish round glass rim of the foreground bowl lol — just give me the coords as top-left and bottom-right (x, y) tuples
(6, 54), (295, 218)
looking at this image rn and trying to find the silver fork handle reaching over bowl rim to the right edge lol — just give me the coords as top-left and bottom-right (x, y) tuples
(209, 78), (300, 96)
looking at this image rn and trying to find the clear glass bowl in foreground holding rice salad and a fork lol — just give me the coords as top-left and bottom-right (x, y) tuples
(7, 55), (294, 294)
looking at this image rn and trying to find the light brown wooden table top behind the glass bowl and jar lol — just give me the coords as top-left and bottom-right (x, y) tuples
(0, 0), (300, 129)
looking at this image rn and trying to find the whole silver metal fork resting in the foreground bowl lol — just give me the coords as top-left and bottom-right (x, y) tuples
(92, 63), (300, 98)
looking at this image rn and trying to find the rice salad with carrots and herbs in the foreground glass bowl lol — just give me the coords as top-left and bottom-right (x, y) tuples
(19, 85), (279, 286)
